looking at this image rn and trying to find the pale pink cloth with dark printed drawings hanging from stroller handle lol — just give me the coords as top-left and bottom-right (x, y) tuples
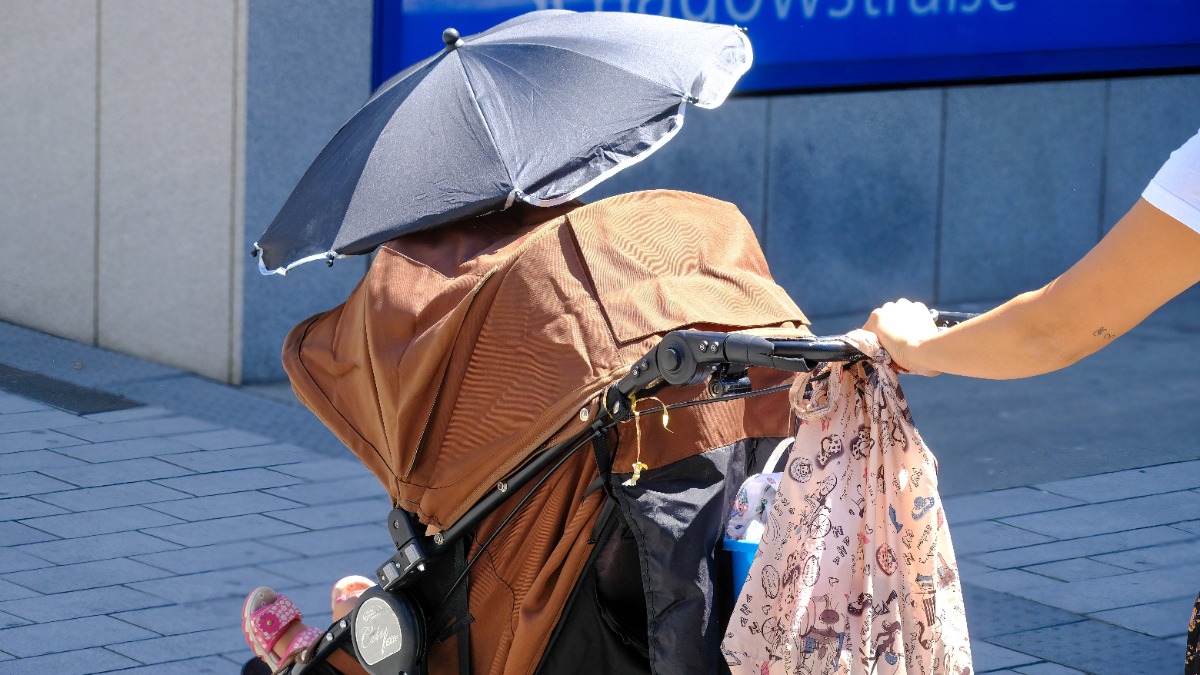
(721, 330), (972, 675)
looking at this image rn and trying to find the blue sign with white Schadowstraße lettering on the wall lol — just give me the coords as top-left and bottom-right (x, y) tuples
(376, 0), (1200, 92)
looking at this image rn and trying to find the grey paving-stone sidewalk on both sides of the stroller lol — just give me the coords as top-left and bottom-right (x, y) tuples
(0, 306), (1200, 675)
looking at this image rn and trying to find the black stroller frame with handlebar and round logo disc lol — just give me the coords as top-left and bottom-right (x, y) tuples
(290, 310), (974, 675)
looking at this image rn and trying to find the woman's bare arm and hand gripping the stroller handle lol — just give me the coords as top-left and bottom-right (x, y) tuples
(865, 199), (1200, 380)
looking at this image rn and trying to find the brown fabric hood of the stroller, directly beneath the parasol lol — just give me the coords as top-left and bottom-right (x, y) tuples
(283, 191), (808, 531)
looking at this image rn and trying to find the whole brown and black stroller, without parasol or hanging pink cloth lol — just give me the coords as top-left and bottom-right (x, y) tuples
(272, 191), (964, 675)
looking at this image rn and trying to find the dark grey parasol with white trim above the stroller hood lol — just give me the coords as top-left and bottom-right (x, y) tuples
(254, 10), (751, 274)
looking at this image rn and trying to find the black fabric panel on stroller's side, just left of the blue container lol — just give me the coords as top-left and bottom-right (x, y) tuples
(612, 438), (778, 675)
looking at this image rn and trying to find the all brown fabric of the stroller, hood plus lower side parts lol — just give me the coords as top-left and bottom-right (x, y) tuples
(283, 191), (808, 673)
